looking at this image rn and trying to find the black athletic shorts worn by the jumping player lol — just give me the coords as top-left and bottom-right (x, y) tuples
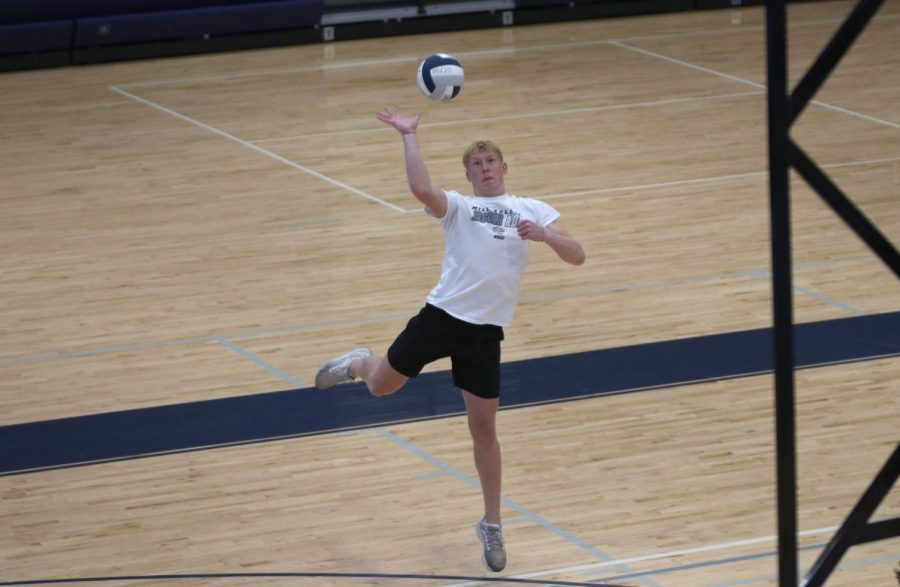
(388, 304), (503, 399)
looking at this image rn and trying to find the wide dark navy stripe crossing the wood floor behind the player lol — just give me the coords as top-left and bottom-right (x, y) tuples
(0, 312), (900, 476)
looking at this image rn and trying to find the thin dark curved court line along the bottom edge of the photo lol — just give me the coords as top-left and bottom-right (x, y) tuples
(0, 573), (627, 587)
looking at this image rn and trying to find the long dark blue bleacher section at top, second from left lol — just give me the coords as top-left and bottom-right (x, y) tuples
(74, 0), (323, 47)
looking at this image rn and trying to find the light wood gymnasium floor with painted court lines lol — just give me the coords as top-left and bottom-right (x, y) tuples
(0, 0), (900, 587)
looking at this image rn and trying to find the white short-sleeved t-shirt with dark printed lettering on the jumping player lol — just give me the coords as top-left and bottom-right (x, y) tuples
(426, 191), (559, 326)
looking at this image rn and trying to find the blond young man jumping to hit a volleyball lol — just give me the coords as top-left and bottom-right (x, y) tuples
(316, 107), (584, 572)
